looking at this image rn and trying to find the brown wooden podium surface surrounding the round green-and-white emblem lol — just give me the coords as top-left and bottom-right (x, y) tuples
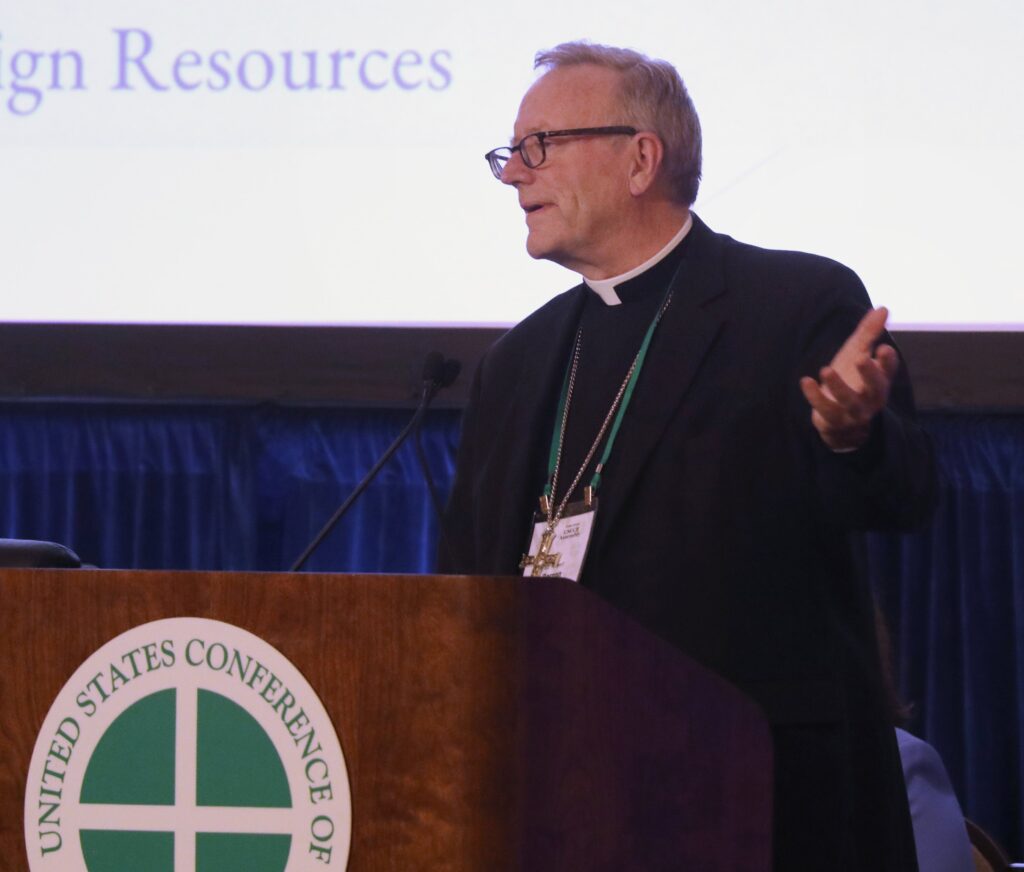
(0, 569), (771, 872)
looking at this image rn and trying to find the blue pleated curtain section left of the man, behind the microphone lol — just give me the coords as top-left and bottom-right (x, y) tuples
(0, 403), (459, 572)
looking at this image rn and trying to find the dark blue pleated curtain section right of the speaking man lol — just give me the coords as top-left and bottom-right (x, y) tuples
(870, 415), (1024, 858)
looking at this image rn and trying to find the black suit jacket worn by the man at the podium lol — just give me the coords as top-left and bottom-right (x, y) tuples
(441, 217), (935, 870)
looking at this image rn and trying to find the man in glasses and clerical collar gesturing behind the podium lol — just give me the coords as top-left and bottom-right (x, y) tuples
(441, 43), (936, 872)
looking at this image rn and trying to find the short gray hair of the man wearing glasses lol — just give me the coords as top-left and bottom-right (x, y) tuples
(534, 41), (700, 206)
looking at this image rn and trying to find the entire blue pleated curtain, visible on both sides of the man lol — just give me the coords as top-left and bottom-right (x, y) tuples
(0, 402), (1024, 857)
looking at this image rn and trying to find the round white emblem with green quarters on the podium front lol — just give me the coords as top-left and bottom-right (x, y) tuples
(25, 618), (351, 872)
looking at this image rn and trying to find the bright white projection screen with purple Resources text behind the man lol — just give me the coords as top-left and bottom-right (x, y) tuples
(0, 0), (1024, 331)
